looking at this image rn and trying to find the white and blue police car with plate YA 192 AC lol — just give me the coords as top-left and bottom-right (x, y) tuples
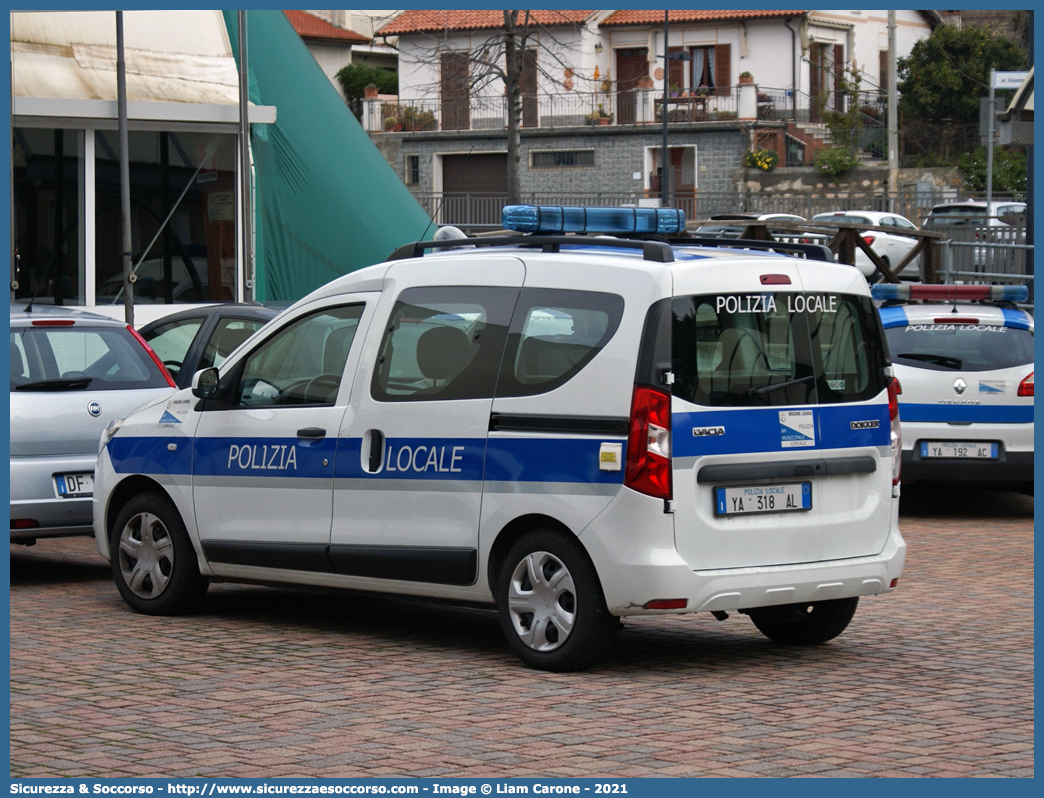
(873, 284), (1034, 494)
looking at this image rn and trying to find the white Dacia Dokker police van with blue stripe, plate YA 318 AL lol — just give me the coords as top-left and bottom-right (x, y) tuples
(95, 206), (906, 671)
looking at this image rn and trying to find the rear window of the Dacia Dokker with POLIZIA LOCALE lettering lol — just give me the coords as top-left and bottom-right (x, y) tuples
(672, 292), (887, 407)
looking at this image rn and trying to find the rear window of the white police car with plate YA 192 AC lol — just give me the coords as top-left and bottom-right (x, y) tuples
(885, 324), (1034, 371)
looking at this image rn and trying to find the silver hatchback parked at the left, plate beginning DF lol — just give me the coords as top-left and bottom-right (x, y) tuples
(10, 305), (174, 544)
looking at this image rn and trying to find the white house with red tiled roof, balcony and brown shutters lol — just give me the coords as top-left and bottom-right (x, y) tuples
(364, 10), (940, 224)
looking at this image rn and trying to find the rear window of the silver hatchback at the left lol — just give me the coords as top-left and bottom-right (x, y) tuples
(10, 325), (169, 391)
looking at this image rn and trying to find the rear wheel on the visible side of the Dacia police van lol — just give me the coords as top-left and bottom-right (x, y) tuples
(496, 530), (620, 673)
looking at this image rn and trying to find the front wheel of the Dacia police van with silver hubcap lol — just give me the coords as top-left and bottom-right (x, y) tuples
(110, 493), (208, 615)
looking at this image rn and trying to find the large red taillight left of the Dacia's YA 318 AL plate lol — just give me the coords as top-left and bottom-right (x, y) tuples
(623, 385), (671, 499)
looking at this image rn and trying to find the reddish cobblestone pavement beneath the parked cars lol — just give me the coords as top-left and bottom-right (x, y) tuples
(10, 489), (1034, 777)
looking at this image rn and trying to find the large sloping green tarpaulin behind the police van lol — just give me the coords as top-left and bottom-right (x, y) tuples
(224, 10), (433, 302)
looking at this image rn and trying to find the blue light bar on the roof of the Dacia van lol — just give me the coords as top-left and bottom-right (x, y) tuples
(501, 205), (685, 235)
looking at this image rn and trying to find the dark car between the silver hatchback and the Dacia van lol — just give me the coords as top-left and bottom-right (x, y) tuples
(140, 304), (280, 388)
